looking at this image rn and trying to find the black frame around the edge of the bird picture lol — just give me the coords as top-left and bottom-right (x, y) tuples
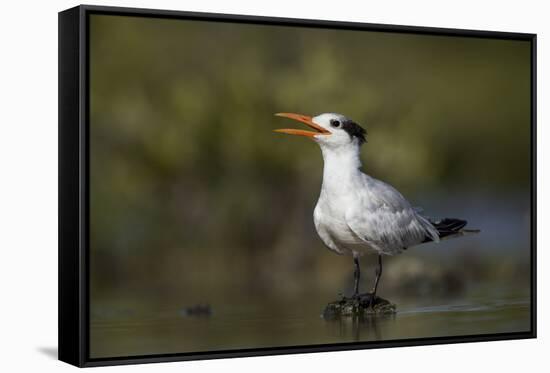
(58, 5), (537, 367)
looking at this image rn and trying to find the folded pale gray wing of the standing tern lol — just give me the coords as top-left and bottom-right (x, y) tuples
(346, 175), (439, 255)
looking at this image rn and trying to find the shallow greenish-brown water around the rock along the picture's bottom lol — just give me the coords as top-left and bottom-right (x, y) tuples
(90, 288), (530, 358)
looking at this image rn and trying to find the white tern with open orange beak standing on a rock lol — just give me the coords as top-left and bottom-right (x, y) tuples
(275, 113), (478, 305)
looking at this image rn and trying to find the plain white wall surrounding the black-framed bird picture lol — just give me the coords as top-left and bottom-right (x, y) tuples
(0, 0), (550, 373)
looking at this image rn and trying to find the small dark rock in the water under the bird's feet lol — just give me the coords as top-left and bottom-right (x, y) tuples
(323, 294), (396, 319)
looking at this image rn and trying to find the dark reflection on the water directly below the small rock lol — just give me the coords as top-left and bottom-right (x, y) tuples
(325, 314), (395, 342)
